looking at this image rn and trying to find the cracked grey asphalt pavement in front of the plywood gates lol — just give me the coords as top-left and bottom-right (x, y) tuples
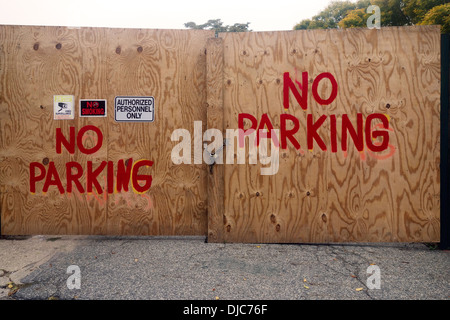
(0, 236), (450, 300)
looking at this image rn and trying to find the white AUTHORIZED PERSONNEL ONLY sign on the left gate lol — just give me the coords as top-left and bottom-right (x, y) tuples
(114, 96), (155, 122)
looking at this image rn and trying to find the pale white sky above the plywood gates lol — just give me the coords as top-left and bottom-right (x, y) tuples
(0, 0), (331, 31)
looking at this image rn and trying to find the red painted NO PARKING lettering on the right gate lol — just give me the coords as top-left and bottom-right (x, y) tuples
(238, 72), (395, 159)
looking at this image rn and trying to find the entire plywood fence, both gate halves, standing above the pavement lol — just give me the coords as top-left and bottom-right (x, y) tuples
(0, 26), (441, 243)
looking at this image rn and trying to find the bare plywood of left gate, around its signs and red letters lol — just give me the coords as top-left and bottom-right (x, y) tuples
(0, 26), (213, 235)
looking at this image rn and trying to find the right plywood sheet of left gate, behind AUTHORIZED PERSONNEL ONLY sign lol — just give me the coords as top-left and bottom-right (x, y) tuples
(103, 30), (212, 235)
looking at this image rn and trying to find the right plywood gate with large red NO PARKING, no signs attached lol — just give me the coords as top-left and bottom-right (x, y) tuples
(207, 26), (440, 243)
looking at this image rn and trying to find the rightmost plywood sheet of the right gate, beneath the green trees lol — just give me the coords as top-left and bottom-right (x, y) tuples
(327, 27), (440, 241)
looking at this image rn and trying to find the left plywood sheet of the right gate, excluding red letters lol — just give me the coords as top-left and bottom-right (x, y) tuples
(222, 31), (327, 242)
